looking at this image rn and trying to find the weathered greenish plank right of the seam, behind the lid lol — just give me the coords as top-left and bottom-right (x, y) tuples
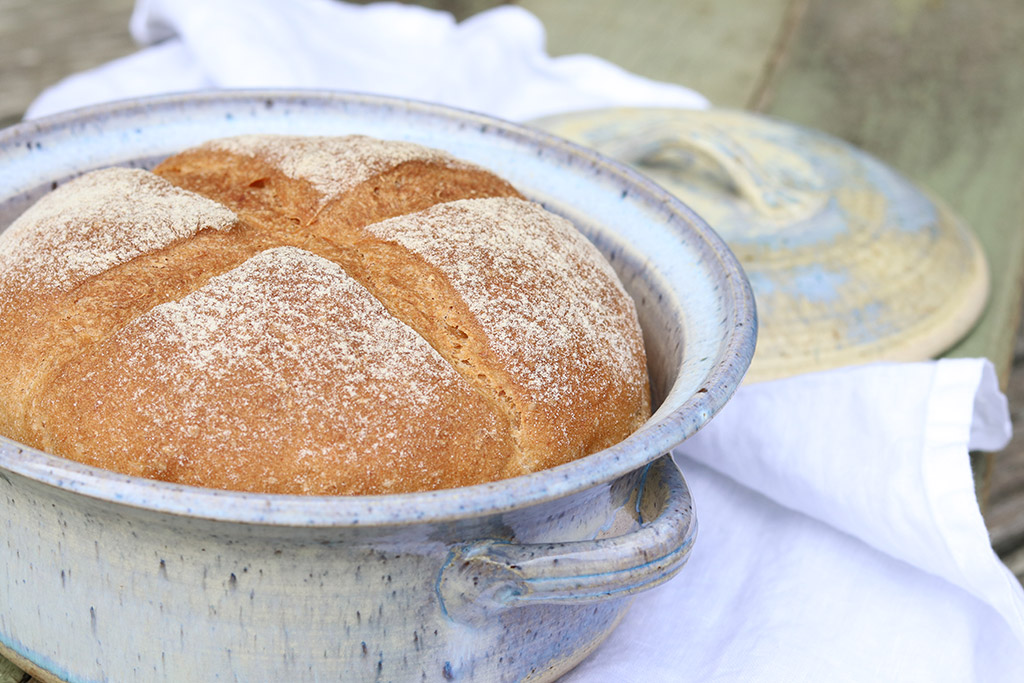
(765, 0), (1024, 383)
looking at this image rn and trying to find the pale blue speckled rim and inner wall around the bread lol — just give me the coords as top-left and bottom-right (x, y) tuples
(0, 91), (757, 525)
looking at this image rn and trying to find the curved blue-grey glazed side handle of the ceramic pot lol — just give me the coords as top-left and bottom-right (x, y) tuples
(437, 455), (696, 623)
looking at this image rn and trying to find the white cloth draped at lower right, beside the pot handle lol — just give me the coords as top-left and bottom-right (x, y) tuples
(565, 359), (1024, 683)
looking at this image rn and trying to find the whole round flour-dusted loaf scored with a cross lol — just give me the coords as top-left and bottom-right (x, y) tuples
(0, 135), (650, 495)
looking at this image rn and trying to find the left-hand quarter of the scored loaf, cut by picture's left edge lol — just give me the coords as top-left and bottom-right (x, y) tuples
(0, 169), (249, 444)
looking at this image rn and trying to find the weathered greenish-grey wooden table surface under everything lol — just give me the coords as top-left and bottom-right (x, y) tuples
(0, 0), (1024, 683)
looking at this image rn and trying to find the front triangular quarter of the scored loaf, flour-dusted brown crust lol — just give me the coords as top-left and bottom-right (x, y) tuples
(38, 247), (510, 495)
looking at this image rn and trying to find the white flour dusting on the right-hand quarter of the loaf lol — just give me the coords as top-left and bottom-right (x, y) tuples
(367, 198), (643, 402)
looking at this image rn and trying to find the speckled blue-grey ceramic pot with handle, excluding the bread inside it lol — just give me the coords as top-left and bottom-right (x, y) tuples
(0, 91), (756, 682)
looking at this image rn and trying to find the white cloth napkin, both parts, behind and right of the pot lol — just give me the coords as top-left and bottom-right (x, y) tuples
(24, 0), (1024, 683)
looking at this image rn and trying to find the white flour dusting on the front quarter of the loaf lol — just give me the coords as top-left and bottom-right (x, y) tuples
(136, 247), (456, 397)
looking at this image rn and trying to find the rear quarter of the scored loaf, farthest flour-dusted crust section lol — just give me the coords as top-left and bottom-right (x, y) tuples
(155, 135), (520, 235)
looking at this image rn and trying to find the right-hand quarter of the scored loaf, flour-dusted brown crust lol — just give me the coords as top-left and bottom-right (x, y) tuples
(339, 198), (649, 476)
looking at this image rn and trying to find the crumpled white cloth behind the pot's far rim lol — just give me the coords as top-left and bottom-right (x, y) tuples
(27, 0), (708, 121)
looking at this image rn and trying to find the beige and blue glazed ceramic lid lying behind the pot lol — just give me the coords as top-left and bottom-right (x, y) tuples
(532, 109), (988, 381)
